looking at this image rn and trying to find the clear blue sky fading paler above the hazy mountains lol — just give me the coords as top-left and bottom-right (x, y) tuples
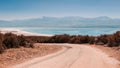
(0, 0), (120, 20)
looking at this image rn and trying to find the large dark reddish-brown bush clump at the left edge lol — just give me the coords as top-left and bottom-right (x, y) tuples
(0, 33), (33, 53)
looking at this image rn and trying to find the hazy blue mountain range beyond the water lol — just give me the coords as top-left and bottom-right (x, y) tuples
(0, 16), (120, 28)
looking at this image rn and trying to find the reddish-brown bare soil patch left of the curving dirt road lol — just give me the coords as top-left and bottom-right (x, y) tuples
(0, 44), (62, 68)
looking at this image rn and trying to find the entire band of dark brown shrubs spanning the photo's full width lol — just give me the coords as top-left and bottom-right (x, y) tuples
(0, 31), (120, 53)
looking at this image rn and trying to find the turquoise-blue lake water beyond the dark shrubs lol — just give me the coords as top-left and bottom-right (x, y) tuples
(23, 28), (120, 36)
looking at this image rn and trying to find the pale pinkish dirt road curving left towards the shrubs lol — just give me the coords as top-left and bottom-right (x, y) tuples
(11, 44), (119, 68)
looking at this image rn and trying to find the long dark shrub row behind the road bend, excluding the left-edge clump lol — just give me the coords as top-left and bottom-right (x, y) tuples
(27, 31), (120, 47)
